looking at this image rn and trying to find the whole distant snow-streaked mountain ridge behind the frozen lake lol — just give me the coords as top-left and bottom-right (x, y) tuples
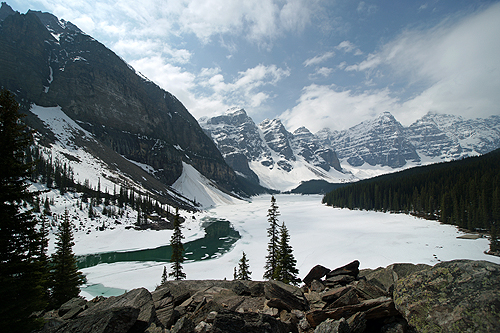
(199, 109), (500, 190)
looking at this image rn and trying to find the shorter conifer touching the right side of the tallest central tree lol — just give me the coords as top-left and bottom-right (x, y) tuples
(274, 222), (300, 285)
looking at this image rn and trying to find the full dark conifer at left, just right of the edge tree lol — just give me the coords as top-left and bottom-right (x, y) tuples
(51, 210), (85, 307)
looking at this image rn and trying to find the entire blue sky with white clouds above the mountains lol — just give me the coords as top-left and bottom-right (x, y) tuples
(6, 0), (500, 132)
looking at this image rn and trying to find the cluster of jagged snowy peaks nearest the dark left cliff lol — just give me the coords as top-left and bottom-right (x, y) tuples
(200, 109), (349, 190)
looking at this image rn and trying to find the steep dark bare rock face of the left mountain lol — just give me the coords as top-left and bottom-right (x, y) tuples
(0, 5), (236, 190)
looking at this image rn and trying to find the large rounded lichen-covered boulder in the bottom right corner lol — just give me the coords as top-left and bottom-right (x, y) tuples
(394, 260), (500, 332)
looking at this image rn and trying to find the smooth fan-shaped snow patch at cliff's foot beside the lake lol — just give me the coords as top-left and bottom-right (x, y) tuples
(172, 162), (241, 208)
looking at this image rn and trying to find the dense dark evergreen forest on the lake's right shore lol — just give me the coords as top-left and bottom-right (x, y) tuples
(323, 149), (500, 230)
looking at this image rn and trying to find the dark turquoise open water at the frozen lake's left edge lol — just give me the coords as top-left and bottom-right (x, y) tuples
(77, 218), (241, 269)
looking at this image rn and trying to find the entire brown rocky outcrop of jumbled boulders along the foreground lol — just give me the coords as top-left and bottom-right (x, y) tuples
(36, 260), (500, 333)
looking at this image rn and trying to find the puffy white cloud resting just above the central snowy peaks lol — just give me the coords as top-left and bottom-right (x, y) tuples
(280, 84), (398, 132)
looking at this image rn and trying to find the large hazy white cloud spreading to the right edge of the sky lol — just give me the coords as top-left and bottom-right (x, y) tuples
(334, 4), (500, 124)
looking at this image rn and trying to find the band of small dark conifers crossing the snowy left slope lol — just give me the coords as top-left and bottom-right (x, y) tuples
(25, 145), (174, 220)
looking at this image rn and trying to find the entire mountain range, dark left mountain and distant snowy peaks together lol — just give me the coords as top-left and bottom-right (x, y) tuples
(0, 3), (500, 200)
